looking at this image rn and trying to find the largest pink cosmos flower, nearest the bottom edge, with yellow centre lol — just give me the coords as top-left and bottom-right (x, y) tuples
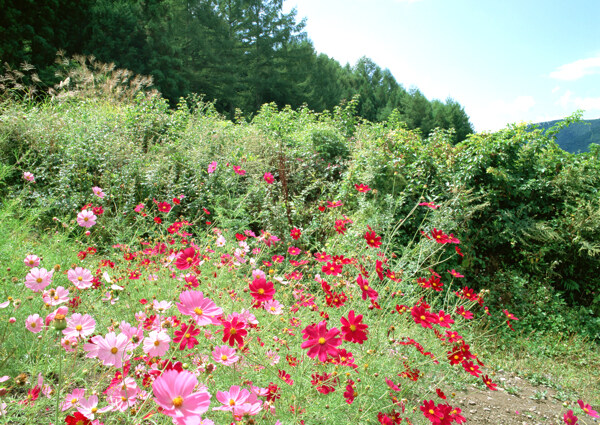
(152, 369), (210, 419)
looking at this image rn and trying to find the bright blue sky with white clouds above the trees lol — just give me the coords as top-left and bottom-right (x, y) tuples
(284, 0), (600, 131)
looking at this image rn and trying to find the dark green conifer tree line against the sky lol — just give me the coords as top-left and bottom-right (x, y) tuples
(0, 0), (473, 141)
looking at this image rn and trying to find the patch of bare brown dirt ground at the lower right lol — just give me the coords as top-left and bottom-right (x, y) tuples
(451, 372), (598, 425)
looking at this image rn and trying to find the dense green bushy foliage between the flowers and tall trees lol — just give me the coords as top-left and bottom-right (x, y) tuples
(0, 73), (600, 337)
